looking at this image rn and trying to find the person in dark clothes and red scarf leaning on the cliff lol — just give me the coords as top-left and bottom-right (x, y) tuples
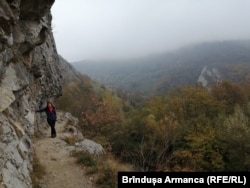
(35, 102), (57, 138)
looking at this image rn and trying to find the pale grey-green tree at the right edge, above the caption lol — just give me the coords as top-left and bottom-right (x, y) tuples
(218, 105), (250, 171)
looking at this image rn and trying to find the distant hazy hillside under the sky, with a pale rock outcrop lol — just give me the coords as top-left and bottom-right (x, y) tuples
(72, 40), (250, 95)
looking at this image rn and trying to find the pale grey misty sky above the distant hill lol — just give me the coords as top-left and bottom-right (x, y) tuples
(52, 0), (250, 62)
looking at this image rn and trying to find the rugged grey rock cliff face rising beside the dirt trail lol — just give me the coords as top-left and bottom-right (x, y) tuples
(0, 0), (62, 188)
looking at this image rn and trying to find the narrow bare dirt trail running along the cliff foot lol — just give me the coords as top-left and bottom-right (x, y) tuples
(34, 112), (97, 188)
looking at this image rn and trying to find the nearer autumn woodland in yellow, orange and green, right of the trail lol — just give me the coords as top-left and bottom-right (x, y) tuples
(57, 54), (250, 173)
